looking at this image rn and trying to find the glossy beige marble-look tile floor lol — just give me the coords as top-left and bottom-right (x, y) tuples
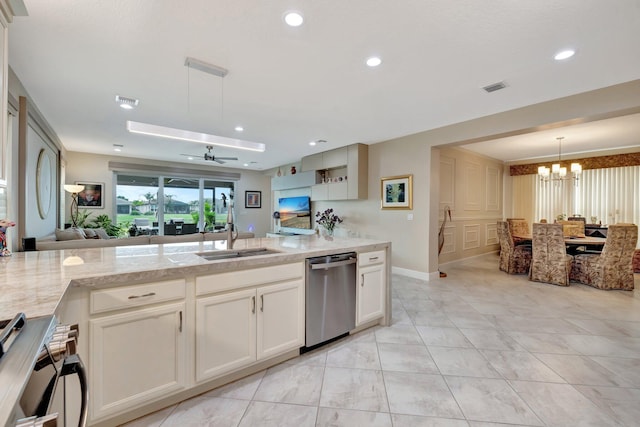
(122, 254), (640, 427)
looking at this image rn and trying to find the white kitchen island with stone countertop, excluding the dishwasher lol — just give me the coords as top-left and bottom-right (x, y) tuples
(0, 235), (391, 425)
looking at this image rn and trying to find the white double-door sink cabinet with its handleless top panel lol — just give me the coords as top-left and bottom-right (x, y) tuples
(196, 262), (304, 381)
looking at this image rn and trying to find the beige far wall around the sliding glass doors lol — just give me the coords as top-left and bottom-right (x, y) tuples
(65, 151), (271, 236)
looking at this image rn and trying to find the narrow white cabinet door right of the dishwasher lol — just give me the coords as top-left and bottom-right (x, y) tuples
(356, 264), (385, 326)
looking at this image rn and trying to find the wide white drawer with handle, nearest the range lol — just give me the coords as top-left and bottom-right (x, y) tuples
(89, 279), (185, 314)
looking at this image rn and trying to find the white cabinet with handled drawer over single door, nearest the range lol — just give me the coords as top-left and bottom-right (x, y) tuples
(89, 280), (186, 419)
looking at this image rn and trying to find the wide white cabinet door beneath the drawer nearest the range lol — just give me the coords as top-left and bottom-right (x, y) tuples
(89, 302), (186, 419)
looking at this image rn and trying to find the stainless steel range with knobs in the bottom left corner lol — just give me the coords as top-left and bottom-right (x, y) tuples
(0, 313), (88, 427)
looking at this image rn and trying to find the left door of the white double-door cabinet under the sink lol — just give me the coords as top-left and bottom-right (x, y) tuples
(196, 289), (256, 381)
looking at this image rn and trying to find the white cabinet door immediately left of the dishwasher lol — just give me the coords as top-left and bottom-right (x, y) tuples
(257, 280), (304, 359)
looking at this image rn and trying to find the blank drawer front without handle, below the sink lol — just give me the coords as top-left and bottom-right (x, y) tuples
(196, 262), (304, 295)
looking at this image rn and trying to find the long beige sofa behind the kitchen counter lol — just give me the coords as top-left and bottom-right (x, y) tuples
(36, 228), (255, 251)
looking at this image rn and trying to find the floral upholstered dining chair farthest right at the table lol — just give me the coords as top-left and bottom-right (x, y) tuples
(571, 224), (638, 291)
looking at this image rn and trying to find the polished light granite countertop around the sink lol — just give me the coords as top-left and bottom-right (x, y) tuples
(0, 235), (391, 319)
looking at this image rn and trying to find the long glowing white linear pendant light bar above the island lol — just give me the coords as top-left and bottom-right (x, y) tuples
(127, 120), (266, 152)
